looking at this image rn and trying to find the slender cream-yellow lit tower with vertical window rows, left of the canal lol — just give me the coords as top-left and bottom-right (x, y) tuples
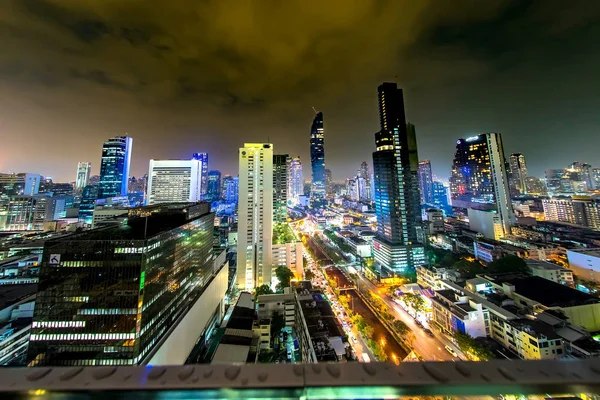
(236, 143), (273, 290)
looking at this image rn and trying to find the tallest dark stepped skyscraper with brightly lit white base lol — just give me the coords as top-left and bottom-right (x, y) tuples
(373, 82), (425, 273)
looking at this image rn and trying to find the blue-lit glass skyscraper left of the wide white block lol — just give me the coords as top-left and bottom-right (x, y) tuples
(98, 136), (133, 199)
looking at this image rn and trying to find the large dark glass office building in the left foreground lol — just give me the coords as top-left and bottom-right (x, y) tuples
(28, 203), (227, 366)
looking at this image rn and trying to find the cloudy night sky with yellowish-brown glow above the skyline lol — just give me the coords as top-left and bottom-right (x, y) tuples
(0, 0), (600, 181)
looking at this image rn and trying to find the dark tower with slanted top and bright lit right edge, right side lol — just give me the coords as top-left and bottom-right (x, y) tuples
(450, 133), (514, 235)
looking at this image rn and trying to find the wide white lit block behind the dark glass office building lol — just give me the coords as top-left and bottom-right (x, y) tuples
(146, 158), (202, 205)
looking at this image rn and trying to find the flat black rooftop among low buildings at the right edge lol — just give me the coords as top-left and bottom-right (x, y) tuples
(486, 274), (600, 307)
